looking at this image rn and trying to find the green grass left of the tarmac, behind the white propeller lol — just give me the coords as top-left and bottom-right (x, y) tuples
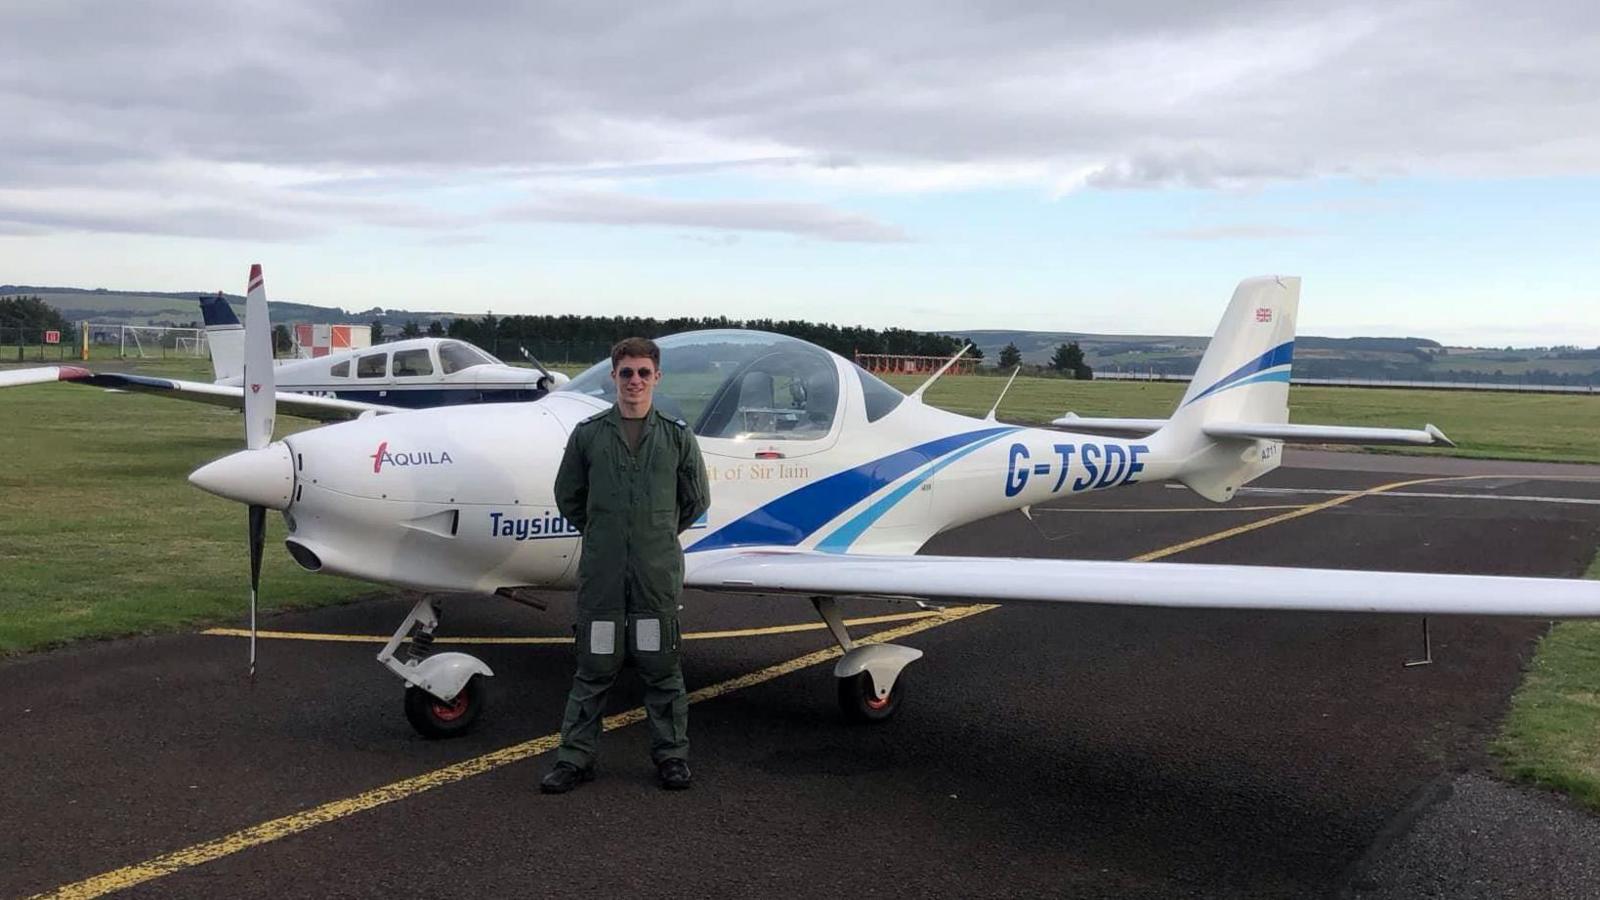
(0, 367), (371, 653)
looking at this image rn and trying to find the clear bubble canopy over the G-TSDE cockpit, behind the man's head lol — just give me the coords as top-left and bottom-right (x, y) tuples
(562, 328), (898, 440)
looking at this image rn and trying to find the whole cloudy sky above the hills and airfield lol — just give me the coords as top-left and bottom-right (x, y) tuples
(0, 0), (1600, 346)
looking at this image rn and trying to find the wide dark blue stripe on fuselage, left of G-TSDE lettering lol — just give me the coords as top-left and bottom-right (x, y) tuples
(688, 426), (1018, 552)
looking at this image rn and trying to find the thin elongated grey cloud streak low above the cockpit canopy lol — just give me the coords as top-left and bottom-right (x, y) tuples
(494, 191), (909, 243)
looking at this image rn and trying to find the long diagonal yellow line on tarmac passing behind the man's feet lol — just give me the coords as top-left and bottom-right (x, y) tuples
(34, 479), (1450, 900)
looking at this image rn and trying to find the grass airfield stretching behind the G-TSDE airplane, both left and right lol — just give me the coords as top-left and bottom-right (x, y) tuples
(0, 359), (1600, 653)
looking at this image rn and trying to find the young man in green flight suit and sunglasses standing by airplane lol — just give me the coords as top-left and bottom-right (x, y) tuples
(539, 338), (710, 794)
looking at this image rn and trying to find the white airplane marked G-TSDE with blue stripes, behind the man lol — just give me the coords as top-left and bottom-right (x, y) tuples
(190, 269), (1600, 737)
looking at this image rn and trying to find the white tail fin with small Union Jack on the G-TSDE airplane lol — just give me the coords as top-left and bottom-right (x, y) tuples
(1150, 275), (1299, 501)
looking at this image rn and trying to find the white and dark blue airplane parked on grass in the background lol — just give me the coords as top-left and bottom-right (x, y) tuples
(0, 298), (568, 421)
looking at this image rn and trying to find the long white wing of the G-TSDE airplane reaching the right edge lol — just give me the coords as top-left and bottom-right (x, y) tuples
(685, 549), (1600, 618)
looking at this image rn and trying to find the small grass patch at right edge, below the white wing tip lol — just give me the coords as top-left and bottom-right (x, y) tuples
(1491, 554), (1600, 810)
